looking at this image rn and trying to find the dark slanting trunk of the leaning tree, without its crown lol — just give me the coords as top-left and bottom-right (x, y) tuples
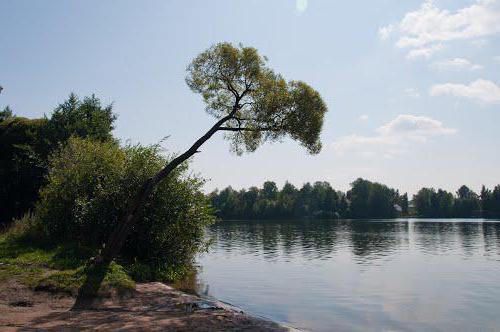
(73, 107), (239, 309)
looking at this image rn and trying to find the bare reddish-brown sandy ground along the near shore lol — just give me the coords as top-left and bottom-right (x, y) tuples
(0, 282), (293, 331)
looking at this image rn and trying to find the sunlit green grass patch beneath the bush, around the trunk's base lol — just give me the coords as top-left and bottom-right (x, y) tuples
(0, 226), (135, 296)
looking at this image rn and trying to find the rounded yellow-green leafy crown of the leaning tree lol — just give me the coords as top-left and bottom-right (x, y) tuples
(186, 43), (327, 154)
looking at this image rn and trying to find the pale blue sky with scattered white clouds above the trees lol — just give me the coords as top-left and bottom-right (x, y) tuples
(0, 0), (500, 194)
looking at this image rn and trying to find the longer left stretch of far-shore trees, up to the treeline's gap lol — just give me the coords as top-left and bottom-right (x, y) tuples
(209, 179), (408, 220)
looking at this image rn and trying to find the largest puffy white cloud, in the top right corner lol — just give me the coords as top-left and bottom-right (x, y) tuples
(379, 0), (500, 58)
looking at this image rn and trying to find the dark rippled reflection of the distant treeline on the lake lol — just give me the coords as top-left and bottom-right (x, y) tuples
(207, 219), (500, 263)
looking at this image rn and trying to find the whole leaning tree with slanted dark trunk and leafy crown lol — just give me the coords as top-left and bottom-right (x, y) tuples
(77, 43), (327, 305)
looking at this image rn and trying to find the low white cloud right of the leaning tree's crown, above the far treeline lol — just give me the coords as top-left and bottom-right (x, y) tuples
(333, 114), (457, 157)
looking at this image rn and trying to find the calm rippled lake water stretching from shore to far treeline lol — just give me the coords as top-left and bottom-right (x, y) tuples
(195, 219), (500, 331)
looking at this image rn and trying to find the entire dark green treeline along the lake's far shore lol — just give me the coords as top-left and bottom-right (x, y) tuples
(209, 178), (500, 220)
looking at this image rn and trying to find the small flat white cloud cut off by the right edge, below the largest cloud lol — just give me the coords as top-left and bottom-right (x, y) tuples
(430, 79), (500, 104)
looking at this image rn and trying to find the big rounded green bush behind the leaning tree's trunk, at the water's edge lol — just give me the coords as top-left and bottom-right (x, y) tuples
(36, 137), (213, 278)
